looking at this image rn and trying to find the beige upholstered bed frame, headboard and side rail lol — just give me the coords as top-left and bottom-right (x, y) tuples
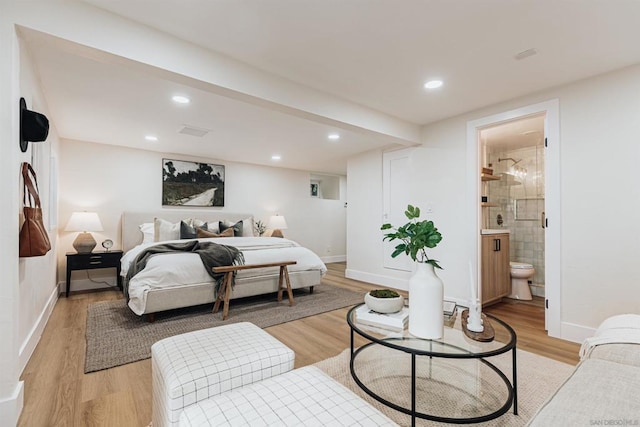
(121, 209), (322, 314)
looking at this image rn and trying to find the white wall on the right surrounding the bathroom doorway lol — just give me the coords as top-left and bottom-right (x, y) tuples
(347, 66), (640, 341)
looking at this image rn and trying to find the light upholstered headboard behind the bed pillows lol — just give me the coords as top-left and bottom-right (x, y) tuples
(122, 209), (253, 252)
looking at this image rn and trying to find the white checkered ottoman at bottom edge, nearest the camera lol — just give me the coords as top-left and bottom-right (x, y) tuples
(175, 366), (396, 427)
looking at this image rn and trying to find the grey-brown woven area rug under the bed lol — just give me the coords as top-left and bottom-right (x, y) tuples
(84, 284), (363, 373)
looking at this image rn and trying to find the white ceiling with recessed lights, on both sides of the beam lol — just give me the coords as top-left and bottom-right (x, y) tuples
(22, 0), (640, 173)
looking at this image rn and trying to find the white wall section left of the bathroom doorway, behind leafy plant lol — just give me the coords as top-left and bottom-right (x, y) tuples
(346, 146), (470, 302)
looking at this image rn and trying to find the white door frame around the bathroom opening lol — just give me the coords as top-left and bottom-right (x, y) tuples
(467, 99), (562, 338)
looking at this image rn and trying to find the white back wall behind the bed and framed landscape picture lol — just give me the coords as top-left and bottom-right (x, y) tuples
(58, 140), (346, 290)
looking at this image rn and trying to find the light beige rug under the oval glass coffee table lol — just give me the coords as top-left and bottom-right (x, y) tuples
(315, 350), (574, 427)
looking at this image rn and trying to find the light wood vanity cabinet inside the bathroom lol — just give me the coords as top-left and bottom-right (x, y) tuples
(481, 233), (511, 304)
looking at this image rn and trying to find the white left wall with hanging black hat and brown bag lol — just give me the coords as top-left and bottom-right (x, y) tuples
(0, 13), (57, 425)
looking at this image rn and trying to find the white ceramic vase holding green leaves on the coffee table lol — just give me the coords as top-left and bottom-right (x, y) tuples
(409, 262), (444, 339)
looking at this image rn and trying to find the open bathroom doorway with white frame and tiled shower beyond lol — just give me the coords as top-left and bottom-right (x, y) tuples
(467, 99), (562, 337)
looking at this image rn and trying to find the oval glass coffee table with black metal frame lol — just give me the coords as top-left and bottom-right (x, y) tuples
(347, 304), (518, 426)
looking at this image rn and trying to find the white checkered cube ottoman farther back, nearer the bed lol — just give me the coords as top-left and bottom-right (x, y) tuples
(151, 322), (295, 427)
